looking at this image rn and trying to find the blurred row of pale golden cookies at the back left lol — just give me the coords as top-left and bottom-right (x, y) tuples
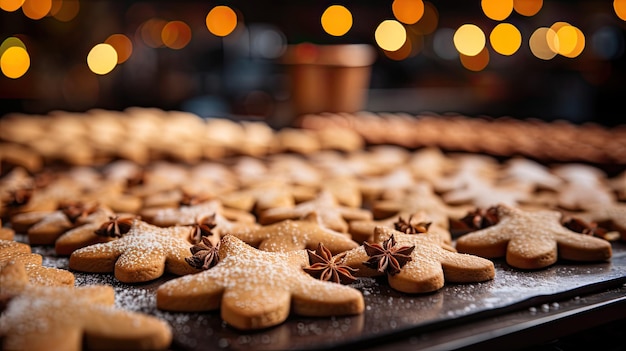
(0, 107), (364, 171)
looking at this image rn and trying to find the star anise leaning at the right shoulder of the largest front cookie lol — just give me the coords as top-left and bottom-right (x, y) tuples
(302, 243), (357, 284)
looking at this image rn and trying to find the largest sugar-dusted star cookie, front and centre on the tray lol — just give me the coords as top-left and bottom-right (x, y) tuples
(157, 235), (364, 330)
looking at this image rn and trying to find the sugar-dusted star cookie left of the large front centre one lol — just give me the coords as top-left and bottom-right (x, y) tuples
(69, 219), (198, 283)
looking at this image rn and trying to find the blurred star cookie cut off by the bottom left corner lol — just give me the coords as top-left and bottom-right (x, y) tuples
(0, 262), (172, 351)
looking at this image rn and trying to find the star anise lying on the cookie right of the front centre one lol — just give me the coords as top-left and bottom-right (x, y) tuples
(363, 235), (415, 275)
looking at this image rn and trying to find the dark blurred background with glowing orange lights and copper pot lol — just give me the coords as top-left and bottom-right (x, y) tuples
(0, 0), (626, 127)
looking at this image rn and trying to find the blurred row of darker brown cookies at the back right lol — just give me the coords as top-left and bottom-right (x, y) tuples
(297, 111), (626, 165)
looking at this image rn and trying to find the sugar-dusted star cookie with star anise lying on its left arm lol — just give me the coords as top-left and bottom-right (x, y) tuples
(340, 227), (495, 294)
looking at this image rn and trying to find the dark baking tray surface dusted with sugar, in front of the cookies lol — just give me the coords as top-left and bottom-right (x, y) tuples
(33, 238), (626, 351)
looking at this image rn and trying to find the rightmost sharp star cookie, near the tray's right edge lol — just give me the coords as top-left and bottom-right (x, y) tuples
(456, 204), (612, 269)
